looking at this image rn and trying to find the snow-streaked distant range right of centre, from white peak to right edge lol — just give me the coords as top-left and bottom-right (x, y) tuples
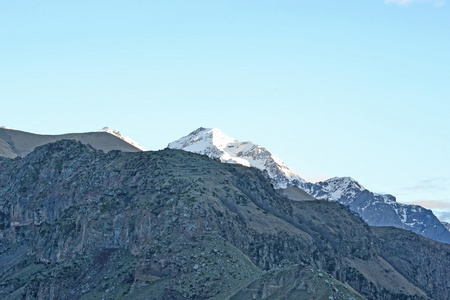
(168, 127), (450, 243)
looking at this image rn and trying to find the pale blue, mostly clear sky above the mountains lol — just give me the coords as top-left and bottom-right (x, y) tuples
(0, 0), (450, 221)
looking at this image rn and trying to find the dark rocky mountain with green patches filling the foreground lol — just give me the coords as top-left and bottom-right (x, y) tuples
(0, 140), (450, 299)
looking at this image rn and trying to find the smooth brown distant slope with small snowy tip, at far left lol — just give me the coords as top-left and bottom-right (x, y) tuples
(0, 127), (143, 158)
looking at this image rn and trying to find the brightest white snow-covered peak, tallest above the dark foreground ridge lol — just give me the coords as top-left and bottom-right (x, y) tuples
(167, 127), (305, 188)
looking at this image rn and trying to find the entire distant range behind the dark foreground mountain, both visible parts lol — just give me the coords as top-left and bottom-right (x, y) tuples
(0, 127), (450, 244)
